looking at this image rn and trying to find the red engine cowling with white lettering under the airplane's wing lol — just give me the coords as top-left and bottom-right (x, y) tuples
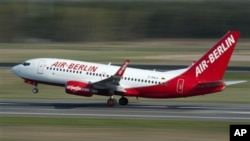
(65, 81), (93, 97)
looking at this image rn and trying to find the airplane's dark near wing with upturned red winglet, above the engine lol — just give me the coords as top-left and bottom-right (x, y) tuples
(91, 60), (129, 92)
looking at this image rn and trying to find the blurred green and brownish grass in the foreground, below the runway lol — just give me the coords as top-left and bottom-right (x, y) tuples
(0, 117), (235, 141)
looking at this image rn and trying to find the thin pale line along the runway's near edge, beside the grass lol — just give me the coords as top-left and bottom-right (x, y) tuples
(0, 112), (250, 120)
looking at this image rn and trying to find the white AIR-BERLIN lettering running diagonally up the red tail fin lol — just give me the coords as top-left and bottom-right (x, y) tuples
(195, 34), (235, 77)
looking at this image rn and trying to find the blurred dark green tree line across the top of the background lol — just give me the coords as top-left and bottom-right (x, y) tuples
(0, 1), (250, 42)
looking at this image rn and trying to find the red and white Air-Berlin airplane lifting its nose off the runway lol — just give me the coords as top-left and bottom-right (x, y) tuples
(11, 31), (246, 106)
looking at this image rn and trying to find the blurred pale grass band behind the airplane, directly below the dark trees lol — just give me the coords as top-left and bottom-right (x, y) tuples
(0, 39), (250, 66)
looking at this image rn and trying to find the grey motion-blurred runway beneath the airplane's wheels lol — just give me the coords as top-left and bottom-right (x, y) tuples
(0, 100), (250, 123)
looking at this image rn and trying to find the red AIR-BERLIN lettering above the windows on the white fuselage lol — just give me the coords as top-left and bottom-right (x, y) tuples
(51, 61), (98, 72)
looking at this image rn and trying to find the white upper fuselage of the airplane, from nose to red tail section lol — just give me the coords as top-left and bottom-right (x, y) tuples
(12, 58), (187, 88)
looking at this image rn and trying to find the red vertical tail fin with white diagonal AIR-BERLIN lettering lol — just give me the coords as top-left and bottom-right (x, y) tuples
(184, 31), (240, 81)
